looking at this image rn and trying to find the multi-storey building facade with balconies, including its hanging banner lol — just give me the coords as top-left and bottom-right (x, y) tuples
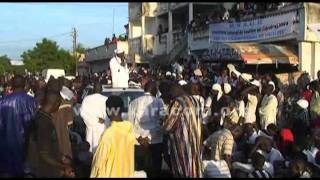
(129, 2), (320, 78)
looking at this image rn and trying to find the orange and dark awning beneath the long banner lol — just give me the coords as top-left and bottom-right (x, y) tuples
(209, 43), (299, 65)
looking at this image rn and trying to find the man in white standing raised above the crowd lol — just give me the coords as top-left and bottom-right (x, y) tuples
(109, 48), (129, 88)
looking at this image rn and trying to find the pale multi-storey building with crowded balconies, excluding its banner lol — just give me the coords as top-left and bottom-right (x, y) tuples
(129, 2), (320, 78)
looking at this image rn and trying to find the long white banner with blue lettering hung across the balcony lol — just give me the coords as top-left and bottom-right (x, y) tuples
(209, 11), (299, 43)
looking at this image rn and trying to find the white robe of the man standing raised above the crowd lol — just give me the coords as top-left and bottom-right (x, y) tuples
(109, 56), (129, 88)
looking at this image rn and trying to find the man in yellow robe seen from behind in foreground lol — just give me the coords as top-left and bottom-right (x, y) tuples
(90, 96), (136, 178)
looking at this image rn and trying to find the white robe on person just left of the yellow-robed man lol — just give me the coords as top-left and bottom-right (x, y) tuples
(80, 94), (110, 153)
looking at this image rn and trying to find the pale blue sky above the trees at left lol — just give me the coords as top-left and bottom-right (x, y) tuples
(0, 3), (128, 60)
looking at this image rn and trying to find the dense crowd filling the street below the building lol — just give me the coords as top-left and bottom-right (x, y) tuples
(0, 53), (320, 178)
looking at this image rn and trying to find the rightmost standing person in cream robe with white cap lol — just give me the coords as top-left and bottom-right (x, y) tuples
(259, 81), (278, 129)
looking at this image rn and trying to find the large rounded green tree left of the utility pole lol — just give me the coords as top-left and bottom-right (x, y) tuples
(21, 38), (75, 74)
